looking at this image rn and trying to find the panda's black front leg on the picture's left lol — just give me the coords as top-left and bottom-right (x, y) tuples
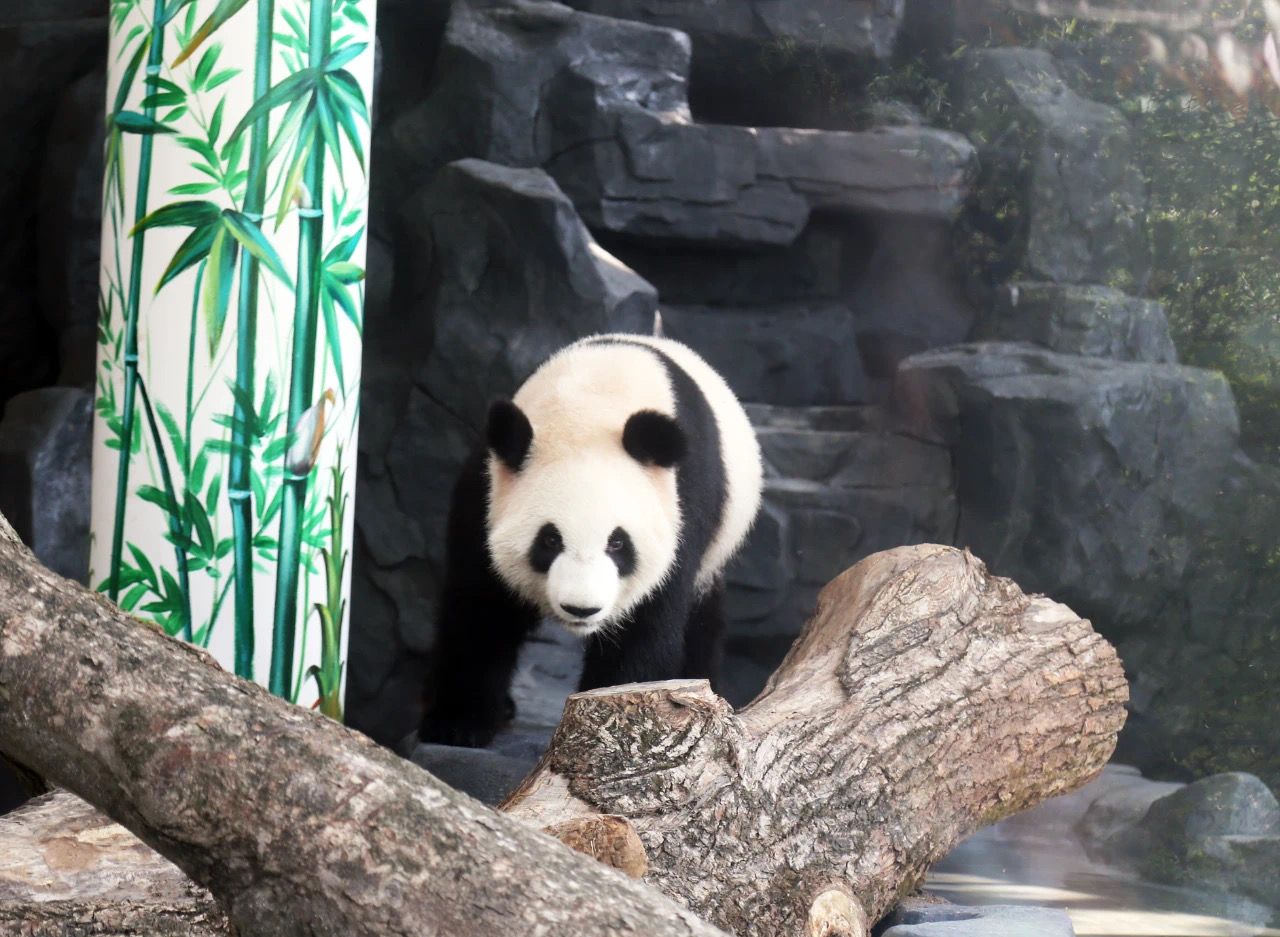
(419, 452), (539, 748)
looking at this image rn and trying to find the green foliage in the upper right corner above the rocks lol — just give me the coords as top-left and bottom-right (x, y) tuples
(962, 3), (1280, 462)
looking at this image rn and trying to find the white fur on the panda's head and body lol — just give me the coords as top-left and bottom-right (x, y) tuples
(489, 334), (762, 635)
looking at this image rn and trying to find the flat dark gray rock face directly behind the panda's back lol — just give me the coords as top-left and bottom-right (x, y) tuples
(662, 303), (868, 406)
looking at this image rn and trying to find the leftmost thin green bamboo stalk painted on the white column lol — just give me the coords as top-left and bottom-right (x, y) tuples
(108, 0), (165, 602)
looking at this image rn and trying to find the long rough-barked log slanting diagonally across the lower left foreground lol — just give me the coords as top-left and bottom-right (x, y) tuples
(0, 518), (723, 937)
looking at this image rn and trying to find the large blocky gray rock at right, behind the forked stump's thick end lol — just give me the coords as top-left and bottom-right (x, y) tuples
(897, 343), (1238, 635)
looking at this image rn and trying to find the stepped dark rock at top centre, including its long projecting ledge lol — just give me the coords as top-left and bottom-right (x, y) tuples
(393, 0), (974, 244)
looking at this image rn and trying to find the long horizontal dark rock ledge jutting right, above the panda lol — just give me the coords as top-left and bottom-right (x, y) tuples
(547, 117), (974, 244)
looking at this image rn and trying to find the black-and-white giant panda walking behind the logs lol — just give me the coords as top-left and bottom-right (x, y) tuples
(419, 334), (763, 748)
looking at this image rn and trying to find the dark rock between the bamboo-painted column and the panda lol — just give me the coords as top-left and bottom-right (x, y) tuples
(347, 160), (657, 741)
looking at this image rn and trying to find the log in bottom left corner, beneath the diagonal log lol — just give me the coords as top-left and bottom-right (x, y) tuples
(0, 791), (236, 937)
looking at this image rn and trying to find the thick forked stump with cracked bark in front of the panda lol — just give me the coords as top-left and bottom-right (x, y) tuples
(502, 545), (1128, 937)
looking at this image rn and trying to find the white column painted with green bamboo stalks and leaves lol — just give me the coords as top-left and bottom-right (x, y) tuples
(91, 0), (375, 719)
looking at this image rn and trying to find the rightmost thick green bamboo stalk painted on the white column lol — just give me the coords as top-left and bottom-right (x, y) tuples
(268, 0), (333, 696)
